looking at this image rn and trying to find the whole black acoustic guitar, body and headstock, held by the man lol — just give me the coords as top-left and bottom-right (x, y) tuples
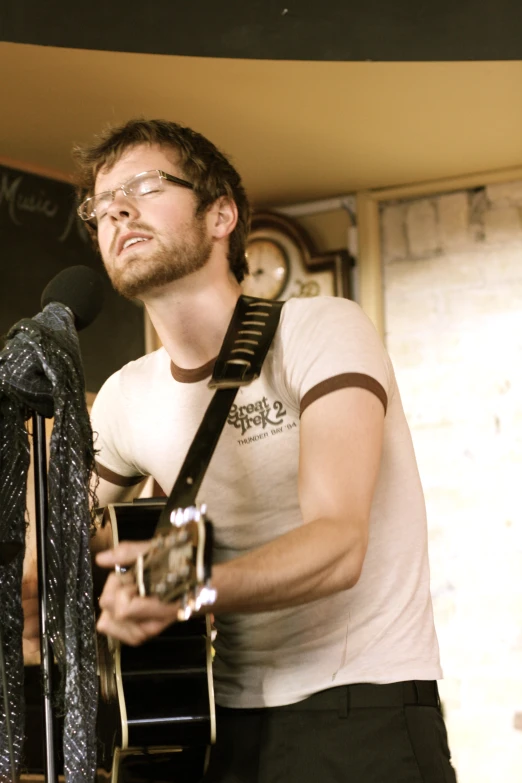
(24, 499), (216, 783)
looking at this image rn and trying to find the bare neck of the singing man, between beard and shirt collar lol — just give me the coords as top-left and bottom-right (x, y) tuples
(143, 273), (241, 370)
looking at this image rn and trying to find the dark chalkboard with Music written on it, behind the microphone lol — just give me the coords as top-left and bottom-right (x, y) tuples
(0, 165), (145, 392)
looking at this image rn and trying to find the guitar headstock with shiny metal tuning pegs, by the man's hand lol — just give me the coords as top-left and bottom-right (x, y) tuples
(134, 505), (216, 620)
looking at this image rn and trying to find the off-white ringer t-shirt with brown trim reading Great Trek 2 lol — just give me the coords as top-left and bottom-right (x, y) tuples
(92, 297), (441, 707)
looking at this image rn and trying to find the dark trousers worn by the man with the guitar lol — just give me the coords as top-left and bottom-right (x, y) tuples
(204, 680), (456, 783)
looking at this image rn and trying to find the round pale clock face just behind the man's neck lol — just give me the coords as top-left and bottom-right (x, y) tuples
(243, 236), (290, 299)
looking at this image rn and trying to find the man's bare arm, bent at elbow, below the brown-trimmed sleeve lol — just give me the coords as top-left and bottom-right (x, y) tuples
(208, 388), (384, 612)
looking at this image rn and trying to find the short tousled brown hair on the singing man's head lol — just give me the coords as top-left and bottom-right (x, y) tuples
(73, 119), (250, 283)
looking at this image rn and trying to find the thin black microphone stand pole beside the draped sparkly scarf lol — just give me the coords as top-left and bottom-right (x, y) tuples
(33, 413), (58, 783)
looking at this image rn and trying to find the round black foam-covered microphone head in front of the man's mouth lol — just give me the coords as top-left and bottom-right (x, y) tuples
(40, 264), (103, 331)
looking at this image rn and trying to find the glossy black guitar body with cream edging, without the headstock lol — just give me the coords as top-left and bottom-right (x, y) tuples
(94, 502), (215, 783)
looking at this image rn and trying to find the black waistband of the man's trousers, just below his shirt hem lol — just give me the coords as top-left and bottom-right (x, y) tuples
(277, 680), (440, 714)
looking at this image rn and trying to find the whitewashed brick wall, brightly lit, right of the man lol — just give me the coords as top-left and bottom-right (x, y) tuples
(381, 182), (522, 783)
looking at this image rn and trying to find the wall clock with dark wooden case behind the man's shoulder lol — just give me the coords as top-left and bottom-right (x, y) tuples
(242, 212), (353, 299)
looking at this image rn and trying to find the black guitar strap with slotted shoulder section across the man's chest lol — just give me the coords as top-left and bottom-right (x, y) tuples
(155, 296), (284, 534)
